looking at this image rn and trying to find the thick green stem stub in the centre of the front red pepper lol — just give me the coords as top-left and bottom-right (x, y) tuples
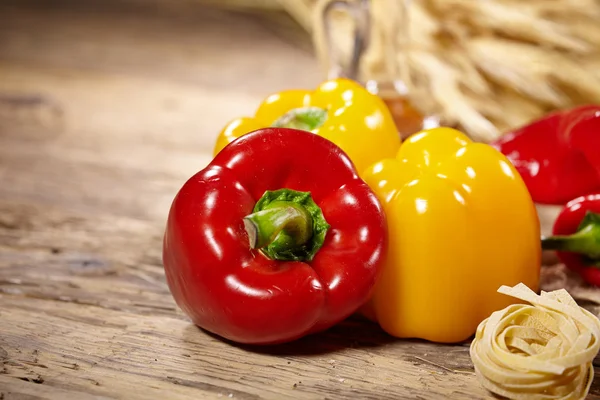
(244, 201), (312, 251)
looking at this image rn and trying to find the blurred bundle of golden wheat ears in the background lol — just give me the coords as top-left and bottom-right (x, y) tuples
(279, 0), (600, 141)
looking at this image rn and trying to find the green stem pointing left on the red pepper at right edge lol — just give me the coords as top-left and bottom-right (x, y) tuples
(542, 212), (600, 260)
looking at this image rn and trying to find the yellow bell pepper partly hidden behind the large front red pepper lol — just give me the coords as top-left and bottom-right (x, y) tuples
(213, 79), (401, 171)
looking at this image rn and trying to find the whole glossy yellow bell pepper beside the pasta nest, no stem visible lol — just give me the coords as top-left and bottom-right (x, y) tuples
(362, 128), (541, 343)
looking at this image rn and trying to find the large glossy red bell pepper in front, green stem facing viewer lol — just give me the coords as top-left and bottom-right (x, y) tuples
(163, 128), (387, 344)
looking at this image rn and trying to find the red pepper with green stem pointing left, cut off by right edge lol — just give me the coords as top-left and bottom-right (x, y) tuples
(542, 193), (600, 286)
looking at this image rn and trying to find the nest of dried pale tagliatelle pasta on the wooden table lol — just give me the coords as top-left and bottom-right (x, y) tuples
(470, 283), (600, 400)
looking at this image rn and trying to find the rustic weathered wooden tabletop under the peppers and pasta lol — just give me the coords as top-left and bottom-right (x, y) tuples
(0, 0), (600, 400)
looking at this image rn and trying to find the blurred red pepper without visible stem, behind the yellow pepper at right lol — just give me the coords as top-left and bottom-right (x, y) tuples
(492, 105), (600, 205)
